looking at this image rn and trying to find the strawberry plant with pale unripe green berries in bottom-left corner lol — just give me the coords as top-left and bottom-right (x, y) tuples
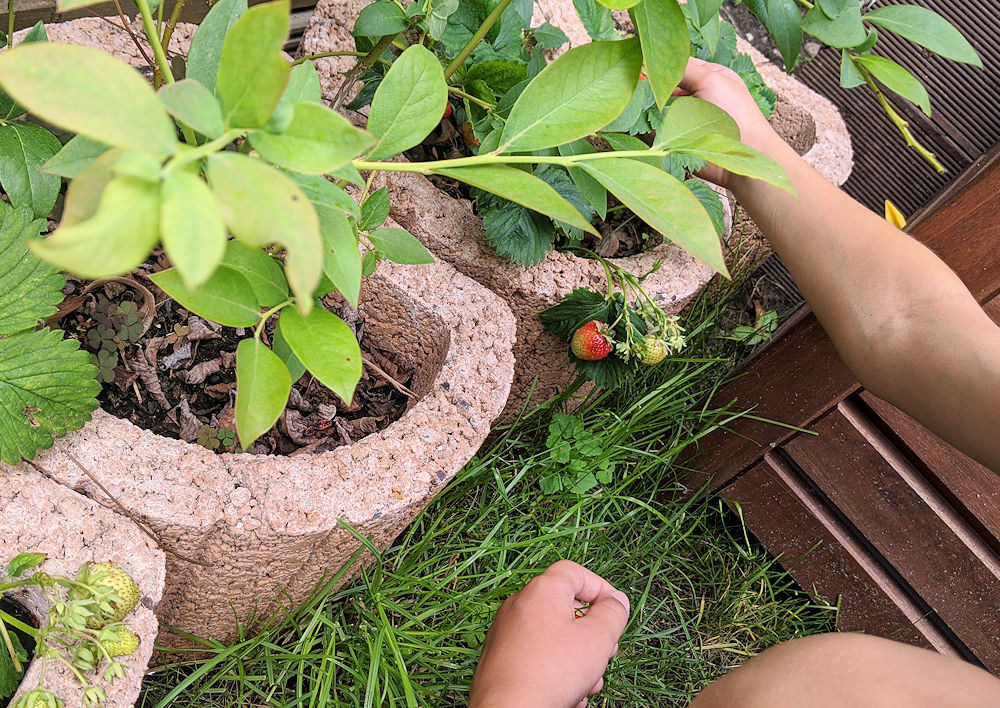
(0, 553), (141, 708)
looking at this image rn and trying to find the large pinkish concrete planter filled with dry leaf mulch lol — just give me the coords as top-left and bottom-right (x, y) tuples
(9, 263), (514, 647)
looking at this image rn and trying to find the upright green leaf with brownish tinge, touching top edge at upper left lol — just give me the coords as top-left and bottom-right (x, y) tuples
(215, 0), (291, 128)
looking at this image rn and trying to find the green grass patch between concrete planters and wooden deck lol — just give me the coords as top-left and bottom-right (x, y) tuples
(140, 274), (832, 708)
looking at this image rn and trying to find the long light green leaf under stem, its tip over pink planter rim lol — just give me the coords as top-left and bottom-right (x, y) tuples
(583, 159), (728, 275)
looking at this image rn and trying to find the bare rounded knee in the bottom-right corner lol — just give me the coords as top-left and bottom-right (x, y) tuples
(692, 634), (1000, 708)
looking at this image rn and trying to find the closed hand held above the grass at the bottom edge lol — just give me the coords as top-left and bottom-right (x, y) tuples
(469, 561), (629, 708)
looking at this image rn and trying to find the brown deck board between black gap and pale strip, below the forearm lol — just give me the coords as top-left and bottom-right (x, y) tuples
(785, 409), (1000, 671)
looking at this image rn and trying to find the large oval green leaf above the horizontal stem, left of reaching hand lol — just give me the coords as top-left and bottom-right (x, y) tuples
(499, 39), (640, 152)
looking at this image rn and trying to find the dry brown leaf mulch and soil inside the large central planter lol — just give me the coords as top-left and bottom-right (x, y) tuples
(58, 264), (414, 455)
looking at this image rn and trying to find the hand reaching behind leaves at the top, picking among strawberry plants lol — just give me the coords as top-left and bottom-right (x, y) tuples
(674, 57), (780, 187)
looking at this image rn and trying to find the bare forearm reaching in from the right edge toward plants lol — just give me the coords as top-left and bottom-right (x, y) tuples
(727, 131), (1000, 471)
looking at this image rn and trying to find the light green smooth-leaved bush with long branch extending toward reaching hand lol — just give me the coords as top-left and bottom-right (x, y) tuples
(0, 0), (789, 448)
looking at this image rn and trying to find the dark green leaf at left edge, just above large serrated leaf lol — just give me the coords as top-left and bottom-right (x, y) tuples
(0, 121), (62, 216)
